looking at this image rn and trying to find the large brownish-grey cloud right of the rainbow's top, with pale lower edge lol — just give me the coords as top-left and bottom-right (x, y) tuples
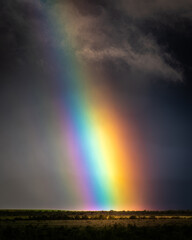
(50, 0), (186, 81)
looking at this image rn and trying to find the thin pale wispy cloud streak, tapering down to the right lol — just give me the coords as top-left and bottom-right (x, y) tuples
(78, 46), (182, 80)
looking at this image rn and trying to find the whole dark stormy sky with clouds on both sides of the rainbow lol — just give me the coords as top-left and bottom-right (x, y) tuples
(0, 0), (192, 209)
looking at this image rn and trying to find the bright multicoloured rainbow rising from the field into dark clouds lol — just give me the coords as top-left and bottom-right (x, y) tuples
(31, 1), (146, 210)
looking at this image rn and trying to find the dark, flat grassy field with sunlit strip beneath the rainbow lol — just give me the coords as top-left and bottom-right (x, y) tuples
(0, 210), (192, 240)
